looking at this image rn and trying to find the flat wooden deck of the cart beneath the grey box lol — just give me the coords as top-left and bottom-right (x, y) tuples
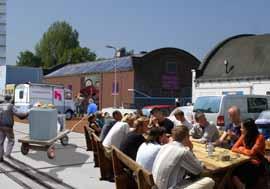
(18, 130), (70, 145)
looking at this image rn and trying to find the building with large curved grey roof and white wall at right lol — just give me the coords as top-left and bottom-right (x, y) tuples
(192, 34), (270, 102)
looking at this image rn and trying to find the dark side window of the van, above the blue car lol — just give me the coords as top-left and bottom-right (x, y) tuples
(247, 98), (268, 113)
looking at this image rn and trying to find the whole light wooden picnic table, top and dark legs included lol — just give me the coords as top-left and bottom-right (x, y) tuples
(193, 142), (250, 188)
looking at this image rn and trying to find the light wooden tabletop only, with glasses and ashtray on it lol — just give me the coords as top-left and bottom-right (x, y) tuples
(193, 142), (250, 172)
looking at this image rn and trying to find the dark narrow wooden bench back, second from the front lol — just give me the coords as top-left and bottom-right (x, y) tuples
(91, 132), (114, 182)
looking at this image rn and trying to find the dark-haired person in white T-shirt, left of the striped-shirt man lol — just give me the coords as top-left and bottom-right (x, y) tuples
(136, 127), (169, 172)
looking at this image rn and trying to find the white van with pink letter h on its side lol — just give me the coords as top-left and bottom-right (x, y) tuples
(14, 83), (75, 119)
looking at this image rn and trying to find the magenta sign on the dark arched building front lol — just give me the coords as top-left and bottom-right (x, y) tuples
(161, 74), (179, 90)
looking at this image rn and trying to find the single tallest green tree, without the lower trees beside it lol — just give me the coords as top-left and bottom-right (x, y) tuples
(36, 22), (79, 68)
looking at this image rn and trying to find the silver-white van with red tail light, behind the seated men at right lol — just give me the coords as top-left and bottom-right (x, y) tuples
(193, 95), (270, 127)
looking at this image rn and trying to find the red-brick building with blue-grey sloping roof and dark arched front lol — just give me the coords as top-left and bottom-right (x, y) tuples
(44, 48), (200, 108)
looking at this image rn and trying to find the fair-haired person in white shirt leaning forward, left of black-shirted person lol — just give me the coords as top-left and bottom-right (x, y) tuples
(102, 114), (135, 148)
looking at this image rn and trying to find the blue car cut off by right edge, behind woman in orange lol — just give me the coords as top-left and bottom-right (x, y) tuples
(255, 110), (270, 139)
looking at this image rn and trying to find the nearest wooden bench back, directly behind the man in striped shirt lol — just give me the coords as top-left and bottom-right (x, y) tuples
(112, 146), (157, 189)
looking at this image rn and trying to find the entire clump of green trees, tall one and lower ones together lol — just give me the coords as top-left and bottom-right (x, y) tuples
(17, 21), (96, 68)
